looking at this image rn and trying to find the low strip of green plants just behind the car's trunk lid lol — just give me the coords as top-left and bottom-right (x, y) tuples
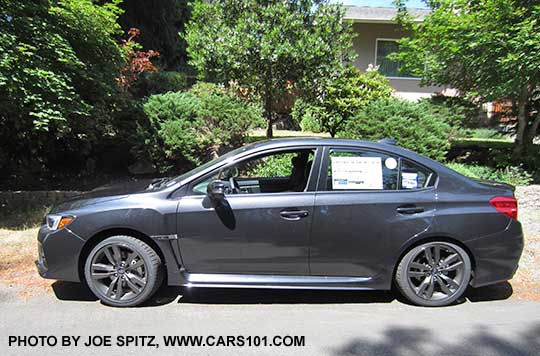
(447, 163), (532, 186)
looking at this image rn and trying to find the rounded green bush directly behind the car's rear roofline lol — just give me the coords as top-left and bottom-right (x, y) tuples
(338, 98), (450, 161)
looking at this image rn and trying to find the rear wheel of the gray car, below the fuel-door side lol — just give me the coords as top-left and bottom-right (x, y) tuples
(395, 241), (471, 307)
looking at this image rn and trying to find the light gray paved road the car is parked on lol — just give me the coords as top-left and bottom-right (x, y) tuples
(0, 283), (540, 356)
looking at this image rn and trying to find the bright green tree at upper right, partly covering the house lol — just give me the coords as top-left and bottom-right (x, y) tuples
(396, 0), (540, 152)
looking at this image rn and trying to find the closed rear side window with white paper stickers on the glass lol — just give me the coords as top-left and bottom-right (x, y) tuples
(326, 149), (435, 191)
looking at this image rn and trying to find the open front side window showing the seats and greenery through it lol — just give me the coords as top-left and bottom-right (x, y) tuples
(191, 149), (315, 195)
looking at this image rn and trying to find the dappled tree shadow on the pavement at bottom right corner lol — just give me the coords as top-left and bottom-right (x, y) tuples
(333, 323), (540, 356)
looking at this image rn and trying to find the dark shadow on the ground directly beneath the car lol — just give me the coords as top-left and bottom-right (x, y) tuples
(52, 281), (512, 307)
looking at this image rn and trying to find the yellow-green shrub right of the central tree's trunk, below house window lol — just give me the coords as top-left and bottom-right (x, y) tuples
(293, 66), (393, 137)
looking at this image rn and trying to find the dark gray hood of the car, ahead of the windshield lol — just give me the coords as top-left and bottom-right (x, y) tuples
(50, 179), (156, 214)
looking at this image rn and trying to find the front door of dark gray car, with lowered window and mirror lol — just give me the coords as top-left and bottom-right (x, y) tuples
(177, 147), (320, 275)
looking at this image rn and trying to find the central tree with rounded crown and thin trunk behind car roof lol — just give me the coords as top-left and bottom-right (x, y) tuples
(185, 0), (352, 137)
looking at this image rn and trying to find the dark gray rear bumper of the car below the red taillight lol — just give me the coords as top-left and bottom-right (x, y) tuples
(465, 220), (523, 287)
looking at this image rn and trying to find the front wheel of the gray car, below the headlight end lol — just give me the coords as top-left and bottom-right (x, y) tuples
(84, 236), (163, 307)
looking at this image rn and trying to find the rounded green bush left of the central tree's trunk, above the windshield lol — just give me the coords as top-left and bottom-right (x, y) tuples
(139, 83), (264, 172)
